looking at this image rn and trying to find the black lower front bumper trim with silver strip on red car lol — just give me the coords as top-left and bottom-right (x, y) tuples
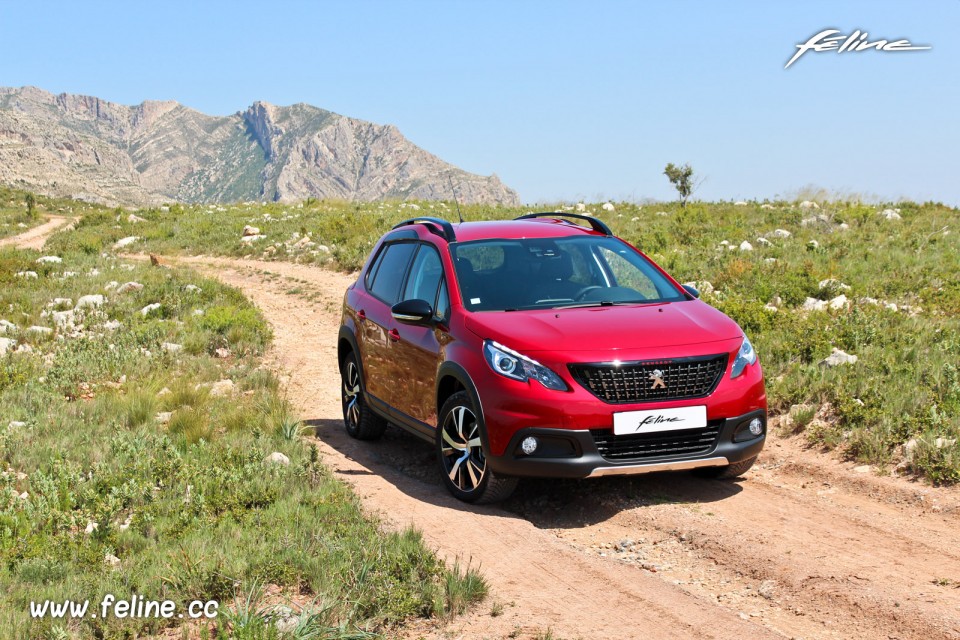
(487, 409), (767, 478)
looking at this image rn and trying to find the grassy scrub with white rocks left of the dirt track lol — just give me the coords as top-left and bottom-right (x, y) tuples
(0, 242), (485, 638)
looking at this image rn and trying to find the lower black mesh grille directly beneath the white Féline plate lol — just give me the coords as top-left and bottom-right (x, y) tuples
(590, 420), (723, 460)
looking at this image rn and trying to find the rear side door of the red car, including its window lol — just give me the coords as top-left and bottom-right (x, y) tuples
(362, 242), (417, 406)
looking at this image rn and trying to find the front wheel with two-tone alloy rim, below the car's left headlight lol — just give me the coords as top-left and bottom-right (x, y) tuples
(436, 391), (519, 504)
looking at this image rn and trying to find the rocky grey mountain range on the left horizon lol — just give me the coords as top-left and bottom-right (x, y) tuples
(0, 87), (519, 206)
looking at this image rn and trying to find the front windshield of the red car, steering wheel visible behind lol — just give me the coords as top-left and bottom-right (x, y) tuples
(450, 236), (687, 311)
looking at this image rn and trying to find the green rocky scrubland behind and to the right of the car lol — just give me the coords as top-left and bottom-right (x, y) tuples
(41, 200), (960, 484)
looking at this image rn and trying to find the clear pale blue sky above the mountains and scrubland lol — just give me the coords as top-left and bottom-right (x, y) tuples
(0, 0), (960, 205)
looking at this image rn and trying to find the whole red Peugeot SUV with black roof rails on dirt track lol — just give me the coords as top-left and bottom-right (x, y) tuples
(337, 213), (767, 502)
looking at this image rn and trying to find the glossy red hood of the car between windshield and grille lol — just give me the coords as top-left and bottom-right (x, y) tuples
(466, 300), (743, 353)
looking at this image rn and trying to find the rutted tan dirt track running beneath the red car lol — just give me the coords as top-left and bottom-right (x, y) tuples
(11, 218), (960, 640)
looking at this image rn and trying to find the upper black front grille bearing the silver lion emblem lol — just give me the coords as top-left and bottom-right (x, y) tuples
(569, 354), (727, 404)
